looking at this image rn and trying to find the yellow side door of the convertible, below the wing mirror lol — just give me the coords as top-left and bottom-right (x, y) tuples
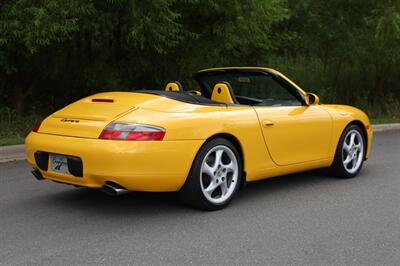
(254, 106), (332, 165)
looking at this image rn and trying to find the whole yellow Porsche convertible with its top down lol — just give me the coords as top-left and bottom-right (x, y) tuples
(26, 67), (372, 210)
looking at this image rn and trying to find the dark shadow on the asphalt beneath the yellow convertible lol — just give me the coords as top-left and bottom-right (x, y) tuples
(42, 170), (338, 216)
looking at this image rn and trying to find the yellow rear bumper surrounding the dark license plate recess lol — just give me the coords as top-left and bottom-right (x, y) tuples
(25, 133), (204, 191)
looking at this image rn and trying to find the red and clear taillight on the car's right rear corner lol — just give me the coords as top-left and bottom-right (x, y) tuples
(99, 123), (165, 140)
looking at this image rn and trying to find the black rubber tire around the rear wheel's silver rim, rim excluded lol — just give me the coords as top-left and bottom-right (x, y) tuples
(179, 138), (243, 211)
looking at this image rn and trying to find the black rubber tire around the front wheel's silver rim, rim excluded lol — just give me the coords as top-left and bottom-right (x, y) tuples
(330, 124), (367, 179)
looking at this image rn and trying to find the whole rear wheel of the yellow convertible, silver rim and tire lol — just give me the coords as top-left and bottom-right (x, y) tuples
(179, 138), (243, 211)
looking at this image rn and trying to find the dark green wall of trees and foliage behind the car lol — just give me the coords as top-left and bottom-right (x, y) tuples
(0, 0), (400, 119)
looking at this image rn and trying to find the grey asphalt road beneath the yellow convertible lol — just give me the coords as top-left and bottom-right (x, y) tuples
(0, 131), (400, 265)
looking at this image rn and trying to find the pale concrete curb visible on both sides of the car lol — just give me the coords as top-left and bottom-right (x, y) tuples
(0, 123), (400, 163)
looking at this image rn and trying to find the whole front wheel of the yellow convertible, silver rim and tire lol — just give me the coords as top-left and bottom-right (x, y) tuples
(330, 124), (366, 178)
